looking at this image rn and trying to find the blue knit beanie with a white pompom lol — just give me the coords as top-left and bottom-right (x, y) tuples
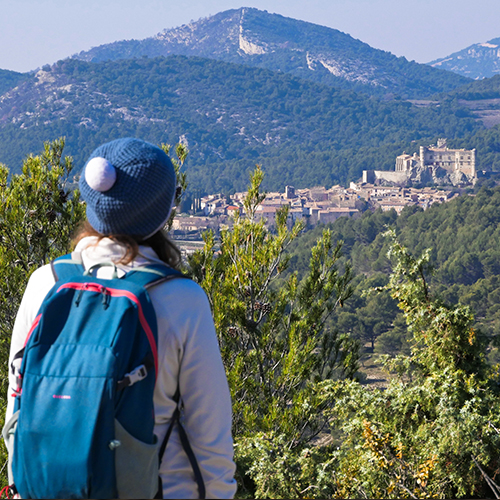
(80, 138), (176, 239)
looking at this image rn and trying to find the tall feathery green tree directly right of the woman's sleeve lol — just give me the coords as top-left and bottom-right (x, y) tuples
(190, 168), (358, 495)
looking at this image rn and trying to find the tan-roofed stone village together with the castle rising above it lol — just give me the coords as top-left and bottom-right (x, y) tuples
(172, 139), (477, 240)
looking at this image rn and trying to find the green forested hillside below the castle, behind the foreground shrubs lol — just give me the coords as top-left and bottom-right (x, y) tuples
(292, 187), (500, 360)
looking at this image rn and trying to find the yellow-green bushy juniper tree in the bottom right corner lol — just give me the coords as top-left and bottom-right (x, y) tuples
(323, 233), (500, 498)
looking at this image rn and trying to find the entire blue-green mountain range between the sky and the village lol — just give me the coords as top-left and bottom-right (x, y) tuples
(0, 8), (500, 193)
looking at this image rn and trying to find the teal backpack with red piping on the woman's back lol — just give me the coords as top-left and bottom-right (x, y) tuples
(3, 255), (204, 498)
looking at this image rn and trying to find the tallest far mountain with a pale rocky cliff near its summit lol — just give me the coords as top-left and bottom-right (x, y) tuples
(73, 7), (467, 98)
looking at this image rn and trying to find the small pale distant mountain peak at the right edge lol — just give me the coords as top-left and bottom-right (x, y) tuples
(429, 38), (500, 80)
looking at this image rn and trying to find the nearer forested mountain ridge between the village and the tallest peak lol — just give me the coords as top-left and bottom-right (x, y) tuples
(0, 56), (483, 192)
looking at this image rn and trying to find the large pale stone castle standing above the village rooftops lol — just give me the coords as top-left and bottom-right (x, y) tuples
(363, 139), (477, 186)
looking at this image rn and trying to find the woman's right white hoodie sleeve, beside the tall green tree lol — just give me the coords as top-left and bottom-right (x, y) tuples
(151, 279), (236, 498)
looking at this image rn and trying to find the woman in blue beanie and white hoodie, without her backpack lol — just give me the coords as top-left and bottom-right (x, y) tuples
(6, 138), (236, 498)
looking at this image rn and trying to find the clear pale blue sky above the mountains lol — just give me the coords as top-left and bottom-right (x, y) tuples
(0, 0), (500, 71)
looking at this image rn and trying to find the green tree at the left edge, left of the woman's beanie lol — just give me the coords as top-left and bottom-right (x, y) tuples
(0, 139), (85, 483)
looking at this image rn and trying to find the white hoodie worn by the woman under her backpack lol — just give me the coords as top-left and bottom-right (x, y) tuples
(6, 237), (236, 498)
